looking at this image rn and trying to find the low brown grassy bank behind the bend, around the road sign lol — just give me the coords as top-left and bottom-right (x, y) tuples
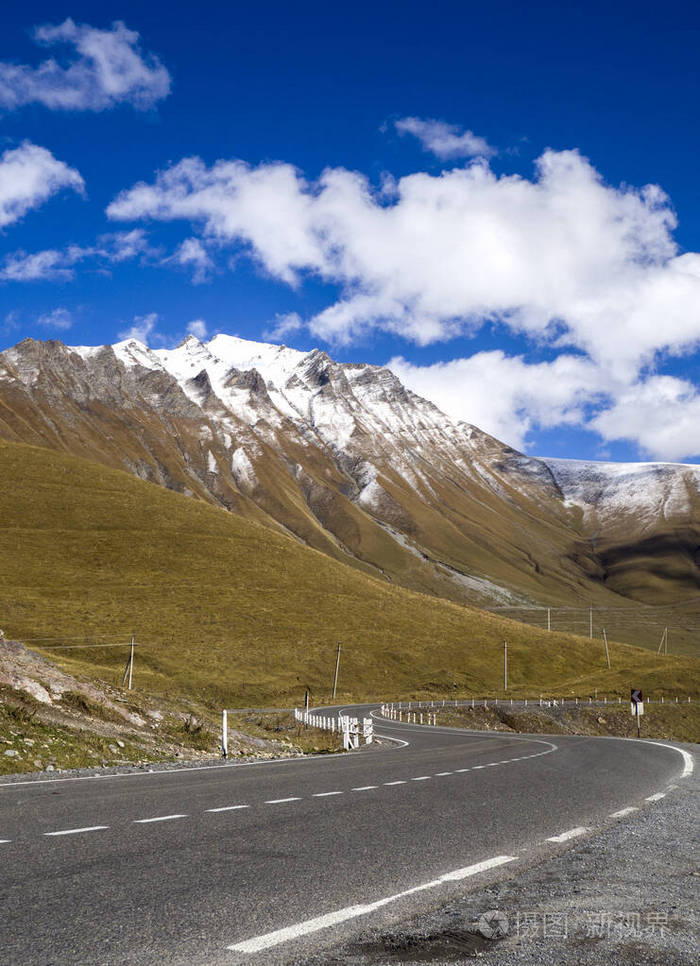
(436, 702), (700, 742)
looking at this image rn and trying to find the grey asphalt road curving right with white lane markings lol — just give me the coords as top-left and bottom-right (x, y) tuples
(0, 709), (689, 966)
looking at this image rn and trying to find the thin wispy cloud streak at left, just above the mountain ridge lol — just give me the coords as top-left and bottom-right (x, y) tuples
(0, 228), (154, 282)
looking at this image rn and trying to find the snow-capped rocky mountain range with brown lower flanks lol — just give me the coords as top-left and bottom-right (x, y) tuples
(0, 335), (700, 602)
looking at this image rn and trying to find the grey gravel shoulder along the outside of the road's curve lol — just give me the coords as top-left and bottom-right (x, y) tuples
(297, 745), (700, 966)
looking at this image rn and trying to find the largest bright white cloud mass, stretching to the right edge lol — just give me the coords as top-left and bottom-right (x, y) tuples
(108, 150), (700, 452)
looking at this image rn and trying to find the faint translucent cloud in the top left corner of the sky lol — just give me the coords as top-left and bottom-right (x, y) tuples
(0, 18), (170, 111)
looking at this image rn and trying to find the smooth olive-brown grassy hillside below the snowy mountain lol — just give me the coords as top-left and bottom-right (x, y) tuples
(0, 443), (698, 706)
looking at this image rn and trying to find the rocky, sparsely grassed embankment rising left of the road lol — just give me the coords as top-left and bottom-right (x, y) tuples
(0, 636), (335, 775)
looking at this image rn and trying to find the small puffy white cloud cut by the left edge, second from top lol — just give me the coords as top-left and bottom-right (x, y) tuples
(0, 141), (84, 229)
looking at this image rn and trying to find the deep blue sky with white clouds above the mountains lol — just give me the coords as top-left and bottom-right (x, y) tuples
(0, 2), (700, 461)
